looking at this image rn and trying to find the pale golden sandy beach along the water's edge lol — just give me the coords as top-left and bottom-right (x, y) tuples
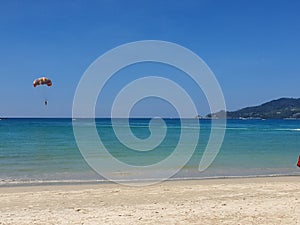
(0, 176), (300, 225)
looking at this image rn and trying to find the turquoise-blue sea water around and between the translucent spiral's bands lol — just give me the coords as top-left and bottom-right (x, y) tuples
(0, 119), (300, 185)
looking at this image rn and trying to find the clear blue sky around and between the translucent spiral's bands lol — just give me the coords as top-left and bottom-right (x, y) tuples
(0, 0), (300, 117)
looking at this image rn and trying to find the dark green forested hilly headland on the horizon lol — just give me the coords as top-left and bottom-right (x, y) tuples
(206, 98), (300, 119)
